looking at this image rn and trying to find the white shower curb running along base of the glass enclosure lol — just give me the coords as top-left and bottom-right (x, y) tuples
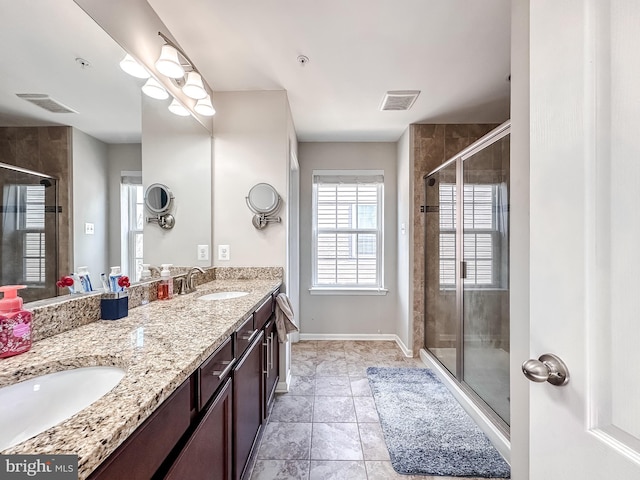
(420, 349), (511, 463)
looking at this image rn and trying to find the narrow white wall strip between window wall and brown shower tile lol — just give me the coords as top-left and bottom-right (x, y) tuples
(396, 128), (417, 353)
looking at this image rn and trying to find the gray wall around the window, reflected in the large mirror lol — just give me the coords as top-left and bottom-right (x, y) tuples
(107, 143), (142, 274)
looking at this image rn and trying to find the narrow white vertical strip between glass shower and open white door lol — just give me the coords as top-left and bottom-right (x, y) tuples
(509, 0), (528, 480)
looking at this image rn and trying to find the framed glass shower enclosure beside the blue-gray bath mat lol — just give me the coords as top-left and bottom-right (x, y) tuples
(424, 122), (510, 437)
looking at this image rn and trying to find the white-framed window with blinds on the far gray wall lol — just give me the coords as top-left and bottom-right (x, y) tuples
(313, 171), (384, 288)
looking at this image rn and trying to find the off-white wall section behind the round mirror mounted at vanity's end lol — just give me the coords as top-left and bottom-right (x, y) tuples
(213, 91), (290, 267)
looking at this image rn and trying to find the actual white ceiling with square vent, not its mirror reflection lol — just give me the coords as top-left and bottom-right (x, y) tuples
(149, 0), (511, 141)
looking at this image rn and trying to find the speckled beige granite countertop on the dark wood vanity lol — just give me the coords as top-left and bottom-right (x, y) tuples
(0, 279), (281, 479)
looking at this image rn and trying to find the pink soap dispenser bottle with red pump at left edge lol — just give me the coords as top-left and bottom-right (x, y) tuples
(0, 285), (31, 358)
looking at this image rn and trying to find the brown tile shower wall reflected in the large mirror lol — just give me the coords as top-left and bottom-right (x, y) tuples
(0, 127), (73, 301)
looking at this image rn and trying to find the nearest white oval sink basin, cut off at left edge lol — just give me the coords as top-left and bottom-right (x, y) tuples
(0, 366), (125, 451)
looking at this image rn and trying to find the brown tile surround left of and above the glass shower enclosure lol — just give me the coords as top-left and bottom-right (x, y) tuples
(411, 124), (498, 355)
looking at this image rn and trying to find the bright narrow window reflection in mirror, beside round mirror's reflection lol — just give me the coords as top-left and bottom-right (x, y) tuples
(121, 172), (144, 281)
